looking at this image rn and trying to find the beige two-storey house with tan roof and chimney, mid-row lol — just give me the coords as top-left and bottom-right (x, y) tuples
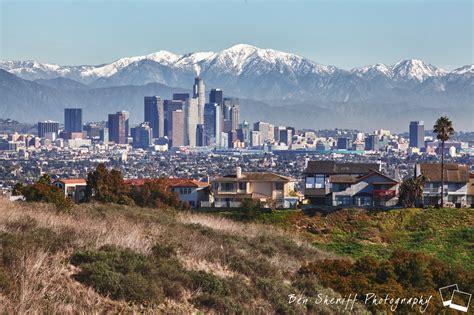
(212, 167), (298, 208)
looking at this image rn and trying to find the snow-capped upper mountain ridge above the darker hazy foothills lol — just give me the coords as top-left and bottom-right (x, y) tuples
(0, 44), (474, 102)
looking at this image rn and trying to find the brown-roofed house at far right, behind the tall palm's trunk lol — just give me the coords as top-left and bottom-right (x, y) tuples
(415, 163), (470, 207)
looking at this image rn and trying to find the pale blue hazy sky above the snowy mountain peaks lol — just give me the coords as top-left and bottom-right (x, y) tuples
(0, 0), (474, 69)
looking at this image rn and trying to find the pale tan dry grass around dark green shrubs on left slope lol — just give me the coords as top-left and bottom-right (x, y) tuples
(0, 198), (346, 314)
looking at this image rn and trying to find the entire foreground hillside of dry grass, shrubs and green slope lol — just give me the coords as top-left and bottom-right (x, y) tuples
(0, 199), (474, 314)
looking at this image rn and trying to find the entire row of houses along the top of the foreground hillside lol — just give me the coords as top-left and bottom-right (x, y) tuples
(50, 161), (474, 209)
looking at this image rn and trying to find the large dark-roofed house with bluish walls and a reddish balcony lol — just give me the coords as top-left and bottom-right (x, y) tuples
(304, 161), (399, 207)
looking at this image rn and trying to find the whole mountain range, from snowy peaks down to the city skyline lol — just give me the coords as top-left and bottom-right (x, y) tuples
(0, 44), (474, 130)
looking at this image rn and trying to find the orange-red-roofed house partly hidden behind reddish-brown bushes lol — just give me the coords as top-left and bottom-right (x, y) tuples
(124, 178), (212, 208)
